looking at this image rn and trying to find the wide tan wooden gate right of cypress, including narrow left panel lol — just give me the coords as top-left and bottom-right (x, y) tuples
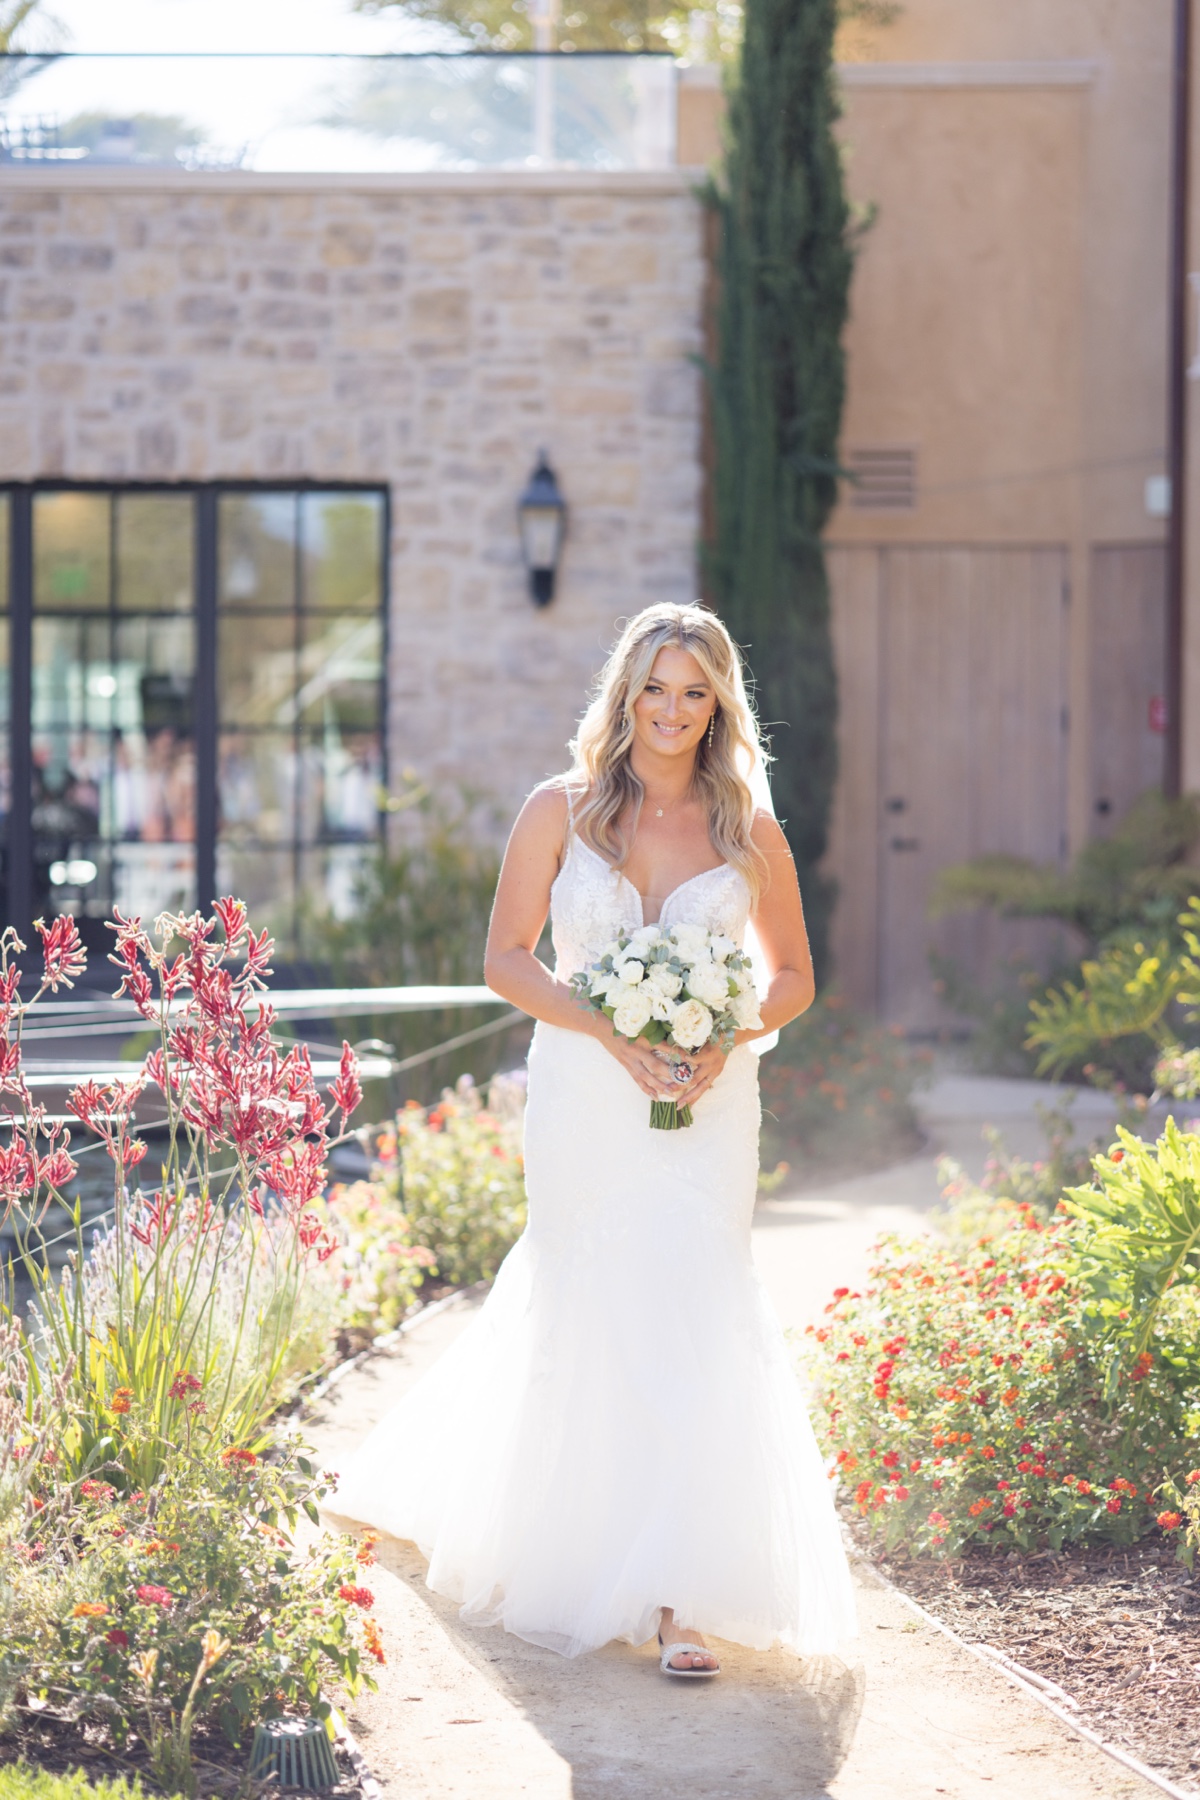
(829, 547), (1069, 1031)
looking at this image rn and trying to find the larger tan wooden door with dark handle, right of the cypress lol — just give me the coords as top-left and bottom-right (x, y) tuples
(878, 547), (1067, 1031)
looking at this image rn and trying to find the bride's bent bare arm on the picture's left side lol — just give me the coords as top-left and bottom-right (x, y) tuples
(484, 788), (676, 1100)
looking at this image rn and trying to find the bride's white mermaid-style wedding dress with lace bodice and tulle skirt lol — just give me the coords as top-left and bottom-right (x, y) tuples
(329, 833), (855, 1656)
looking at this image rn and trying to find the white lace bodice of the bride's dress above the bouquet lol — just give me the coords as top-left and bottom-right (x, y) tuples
(551, 832), (750, 979)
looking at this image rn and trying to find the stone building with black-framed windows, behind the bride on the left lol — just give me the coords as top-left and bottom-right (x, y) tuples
(0, 156), (703, 940)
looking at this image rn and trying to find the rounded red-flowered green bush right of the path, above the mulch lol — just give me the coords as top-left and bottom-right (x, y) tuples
(810, 1159), (1195, 1555)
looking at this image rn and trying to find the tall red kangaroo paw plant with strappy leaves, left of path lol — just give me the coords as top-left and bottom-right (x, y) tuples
(8, 898), (362, 1487)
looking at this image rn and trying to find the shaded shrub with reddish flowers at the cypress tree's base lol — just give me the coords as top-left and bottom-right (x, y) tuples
(759, 995), (932, 1172)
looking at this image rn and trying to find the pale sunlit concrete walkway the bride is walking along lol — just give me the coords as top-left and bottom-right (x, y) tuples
(309, 1078), (1155, 1800)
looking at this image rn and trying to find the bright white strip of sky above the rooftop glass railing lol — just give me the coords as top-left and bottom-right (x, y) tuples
(43, 0), (446, 54)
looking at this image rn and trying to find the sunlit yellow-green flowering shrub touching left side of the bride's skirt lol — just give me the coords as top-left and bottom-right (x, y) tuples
(370, 1076), (525, 1287)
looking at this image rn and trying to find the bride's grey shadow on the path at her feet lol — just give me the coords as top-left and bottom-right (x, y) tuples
(376, 1537), (864, 1800)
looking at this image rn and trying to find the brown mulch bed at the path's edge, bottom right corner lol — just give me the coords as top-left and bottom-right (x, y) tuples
(855, 1532), (1200, 1795)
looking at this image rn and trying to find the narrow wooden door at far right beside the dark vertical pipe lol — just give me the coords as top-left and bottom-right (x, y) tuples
(1088, 544), (1166, 837)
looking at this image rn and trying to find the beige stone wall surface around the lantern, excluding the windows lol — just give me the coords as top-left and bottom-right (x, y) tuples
(0, 169), (703, 831)
